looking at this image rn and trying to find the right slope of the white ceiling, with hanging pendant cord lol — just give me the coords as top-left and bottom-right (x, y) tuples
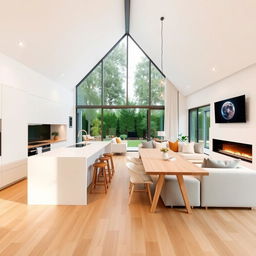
(131, 0), (256, 95)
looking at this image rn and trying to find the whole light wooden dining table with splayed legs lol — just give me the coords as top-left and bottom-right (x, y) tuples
(139, 148), (209, 213)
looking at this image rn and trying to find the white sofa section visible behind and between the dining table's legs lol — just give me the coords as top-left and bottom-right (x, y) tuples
(161, 175), (200, 206)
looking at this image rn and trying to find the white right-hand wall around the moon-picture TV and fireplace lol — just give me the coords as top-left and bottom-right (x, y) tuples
(187, 65), (256, 168)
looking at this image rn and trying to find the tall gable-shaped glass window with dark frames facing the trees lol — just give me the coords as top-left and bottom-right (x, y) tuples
(76, 36), (164, 148)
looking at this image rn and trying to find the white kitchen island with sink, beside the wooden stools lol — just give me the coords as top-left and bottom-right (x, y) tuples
(28, 141), (110, 205)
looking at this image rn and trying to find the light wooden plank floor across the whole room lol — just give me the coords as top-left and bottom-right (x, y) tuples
(0, 153), (256, 256)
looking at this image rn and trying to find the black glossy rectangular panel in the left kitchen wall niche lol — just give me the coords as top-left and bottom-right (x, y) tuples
(28, 124), (51, 142)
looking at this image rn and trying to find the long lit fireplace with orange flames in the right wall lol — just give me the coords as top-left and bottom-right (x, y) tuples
(212, 139), (252, 163)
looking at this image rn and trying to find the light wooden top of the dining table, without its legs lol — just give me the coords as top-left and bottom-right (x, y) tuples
(140, 148), (209, 175)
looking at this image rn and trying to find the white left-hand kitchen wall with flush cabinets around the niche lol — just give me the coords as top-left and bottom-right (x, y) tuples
(0, 53), (75, 165)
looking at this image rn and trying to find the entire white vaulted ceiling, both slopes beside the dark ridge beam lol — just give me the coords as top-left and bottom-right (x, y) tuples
(0, 0), (256, 95)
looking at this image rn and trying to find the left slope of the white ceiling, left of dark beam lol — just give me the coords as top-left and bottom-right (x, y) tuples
(0, 0), (124, 88)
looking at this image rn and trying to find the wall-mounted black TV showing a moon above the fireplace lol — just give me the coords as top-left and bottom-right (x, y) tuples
(214, 95), (246, 123)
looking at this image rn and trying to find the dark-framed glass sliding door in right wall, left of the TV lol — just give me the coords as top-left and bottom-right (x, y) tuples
(189, 106), (210, 148)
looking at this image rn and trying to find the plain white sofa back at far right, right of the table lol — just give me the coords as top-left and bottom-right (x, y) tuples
(201, 167), (256, 207)
